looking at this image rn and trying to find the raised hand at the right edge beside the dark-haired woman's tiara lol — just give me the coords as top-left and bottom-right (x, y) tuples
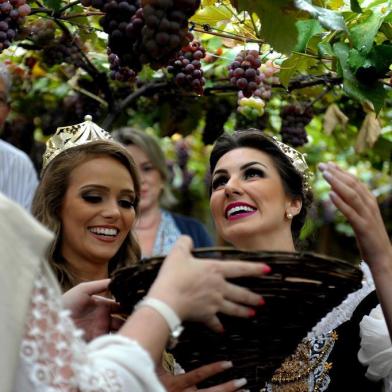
(319, 163), (392, 269)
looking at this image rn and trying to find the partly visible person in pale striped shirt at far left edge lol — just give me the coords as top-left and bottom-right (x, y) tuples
(0, 63), (38, 210)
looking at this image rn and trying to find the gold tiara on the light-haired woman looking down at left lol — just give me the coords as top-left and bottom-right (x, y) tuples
(42, 115), (113, 170)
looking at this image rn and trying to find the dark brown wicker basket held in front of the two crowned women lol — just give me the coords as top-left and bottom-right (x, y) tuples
(110, 248), (362, 391)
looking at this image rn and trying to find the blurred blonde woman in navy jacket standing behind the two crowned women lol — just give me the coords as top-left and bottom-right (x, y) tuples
(112, 127), (213, 257)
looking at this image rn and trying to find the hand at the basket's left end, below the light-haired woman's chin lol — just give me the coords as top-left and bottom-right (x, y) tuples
(63, 279), (123, 341)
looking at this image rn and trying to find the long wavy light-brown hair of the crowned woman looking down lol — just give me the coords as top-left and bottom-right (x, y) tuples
(32, 141), (141, 291)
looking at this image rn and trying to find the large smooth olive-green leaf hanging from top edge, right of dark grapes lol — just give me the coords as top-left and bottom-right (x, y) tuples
(231, 0), (297, 54)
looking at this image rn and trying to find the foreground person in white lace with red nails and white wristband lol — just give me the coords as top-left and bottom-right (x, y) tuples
(0, 193), (265, 392)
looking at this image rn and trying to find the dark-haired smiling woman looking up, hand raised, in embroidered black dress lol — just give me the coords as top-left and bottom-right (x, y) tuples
(210, 129), (392, 392)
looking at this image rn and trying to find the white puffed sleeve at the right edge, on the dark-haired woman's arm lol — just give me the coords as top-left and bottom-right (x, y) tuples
(358, 305), (392, 391)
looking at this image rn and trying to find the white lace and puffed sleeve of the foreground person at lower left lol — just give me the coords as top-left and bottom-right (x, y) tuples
(13, 265), (164, 392)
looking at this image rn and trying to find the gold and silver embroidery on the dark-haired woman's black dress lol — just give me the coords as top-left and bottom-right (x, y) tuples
(267, 331), (338, 392)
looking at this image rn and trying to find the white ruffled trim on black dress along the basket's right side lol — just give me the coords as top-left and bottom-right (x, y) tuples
(307, 262), (375, 339)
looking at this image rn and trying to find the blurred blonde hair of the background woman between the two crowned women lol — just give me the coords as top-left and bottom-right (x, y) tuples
(112, 127), (177, 208)
